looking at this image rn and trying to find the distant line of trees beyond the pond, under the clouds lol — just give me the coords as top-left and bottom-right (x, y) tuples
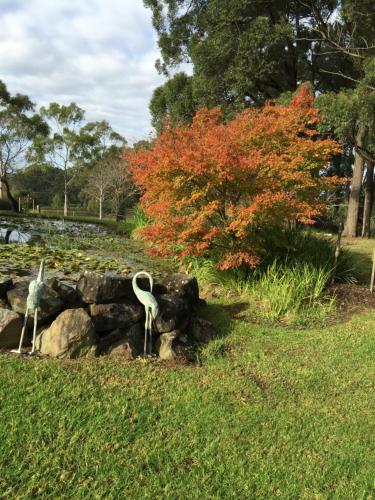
(0, 81), (142, 218)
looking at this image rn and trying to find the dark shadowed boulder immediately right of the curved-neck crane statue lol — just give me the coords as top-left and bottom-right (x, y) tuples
(154, 295), (191, 333)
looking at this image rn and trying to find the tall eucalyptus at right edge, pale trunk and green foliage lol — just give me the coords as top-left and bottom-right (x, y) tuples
(309, 0), (375, 237)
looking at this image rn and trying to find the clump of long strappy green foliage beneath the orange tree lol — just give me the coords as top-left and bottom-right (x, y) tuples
(188, 231), (355, 326)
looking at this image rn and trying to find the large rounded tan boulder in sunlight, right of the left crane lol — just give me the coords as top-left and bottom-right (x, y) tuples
(36, 308), (96, 358)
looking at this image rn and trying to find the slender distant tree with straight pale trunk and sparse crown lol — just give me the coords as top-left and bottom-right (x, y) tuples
(40, 102), (85, 217)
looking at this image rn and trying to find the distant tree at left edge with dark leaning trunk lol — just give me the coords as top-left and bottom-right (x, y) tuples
(0, 81), (48, 211)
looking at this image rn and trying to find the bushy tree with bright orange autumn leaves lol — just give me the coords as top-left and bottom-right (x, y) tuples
(129, 86), (341, 269)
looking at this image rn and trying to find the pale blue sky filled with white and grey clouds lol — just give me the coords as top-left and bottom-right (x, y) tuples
(0, 0), (169, 143)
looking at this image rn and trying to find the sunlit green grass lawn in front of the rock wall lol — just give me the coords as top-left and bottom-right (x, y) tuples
(0, 304), (375, 499)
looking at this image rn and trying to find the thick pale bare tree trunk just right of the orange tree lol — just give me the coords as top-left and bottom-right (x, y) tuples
(343, 126), (365, 238)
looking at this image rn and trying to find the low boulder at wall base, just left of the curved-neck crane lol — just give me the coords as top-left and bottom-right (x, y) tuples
(103, 324), (144, 360)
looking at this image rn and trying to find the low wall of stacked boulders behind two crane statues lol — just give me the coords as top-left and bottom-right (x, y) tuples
(0, 271), (215, 360)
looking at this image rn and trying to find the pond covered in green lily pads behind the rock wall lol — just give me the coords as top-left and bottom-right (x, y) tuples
(0, 216), (176, 282)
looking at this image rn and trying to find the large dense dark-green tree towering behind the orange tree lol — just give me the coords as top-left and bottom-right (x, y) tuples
(144, 0), (356, 128)
